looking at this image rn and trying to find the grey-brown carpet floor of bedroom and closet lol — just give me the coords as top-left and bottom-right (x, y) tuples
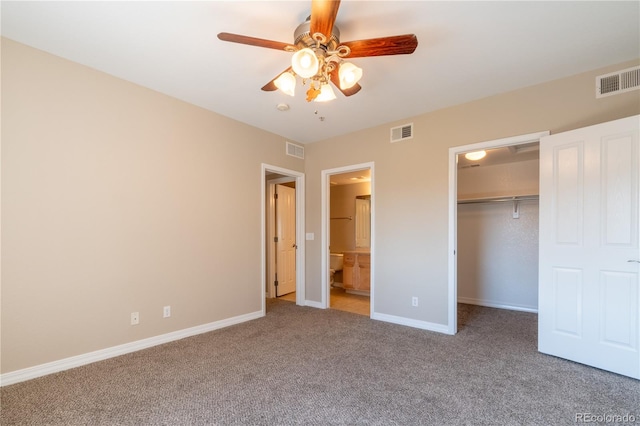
(0, 300), (640, 425)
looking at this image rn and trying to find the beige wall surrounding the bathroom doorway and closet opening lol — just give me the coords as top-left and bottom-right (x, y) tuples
(305, 60), (640, 324)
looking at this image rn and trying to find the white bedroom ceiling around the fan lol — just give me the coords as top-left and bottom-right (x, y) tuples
(1, 0), (640, 143)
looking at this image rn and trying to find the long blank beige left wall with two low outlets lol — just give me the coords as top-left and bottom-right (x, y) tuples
(1, 39), (304, 373)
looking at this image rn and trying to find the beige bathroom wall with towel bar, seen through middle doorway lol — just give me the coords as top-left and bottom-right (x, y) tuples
(329, 182), (371, 253)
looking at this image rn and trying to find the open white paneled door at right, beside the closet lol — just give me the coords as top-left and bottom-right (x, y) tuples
(538, 116), (640, 378)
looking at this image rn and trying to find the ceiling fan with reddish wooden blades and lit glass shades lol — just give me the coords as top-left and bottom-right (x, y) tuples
(218, 0), (418, 102)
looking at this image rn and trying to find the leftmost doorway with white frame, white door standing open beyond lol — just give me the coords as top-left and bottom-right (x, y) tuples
(261, 164), (305, 315)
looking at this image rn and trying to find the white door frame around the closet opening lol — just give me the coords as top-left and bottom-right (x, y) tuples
(447, 131), (549, 334)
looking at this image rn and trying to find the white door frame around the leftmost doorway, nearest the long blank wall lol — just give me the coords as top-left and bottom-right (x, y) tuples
(260, 163), (306, 315)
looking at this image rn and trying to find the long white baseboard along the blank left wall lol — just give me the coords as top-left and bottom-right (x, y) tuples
(0, 311), (264, 387)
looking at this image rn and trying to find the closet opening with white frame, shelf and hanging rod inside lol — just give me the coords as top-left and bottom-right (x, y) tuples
(449, 132), (548, 334)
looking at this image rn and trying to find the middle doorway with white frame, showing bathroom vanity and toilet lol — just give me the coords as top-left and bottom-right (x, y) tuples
(322, 163), (375, 316)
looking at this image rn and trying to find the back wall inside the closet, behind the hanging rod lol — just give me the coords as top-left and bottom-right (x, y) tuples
(458, 160), (539, 311)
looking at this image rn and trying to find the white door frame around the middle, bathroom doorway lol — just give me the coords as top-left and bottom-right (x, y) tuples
(320, 161), (376, 317)
